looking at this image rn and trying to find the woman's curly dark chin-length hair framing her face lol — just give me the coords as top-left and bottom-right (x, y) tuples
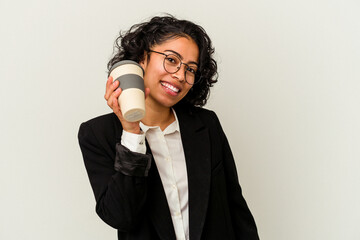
(107, 15), (218, 107)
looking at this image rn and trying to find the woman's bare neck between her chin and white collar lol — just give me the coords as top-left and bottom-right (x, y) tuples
(141, 102), (175, 131)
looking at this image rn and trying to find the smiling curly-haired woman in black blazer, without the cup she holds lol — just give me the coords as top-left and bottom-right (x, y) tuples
(79, 16), (258, 240)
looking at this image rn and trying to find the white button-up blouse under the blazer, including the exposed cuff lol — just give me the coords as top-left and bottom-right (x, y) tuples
(121, 109), (189, 240)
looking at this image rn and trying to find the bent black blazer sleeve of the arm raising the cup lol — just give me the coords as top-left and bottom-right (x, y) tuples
(78, 122), (151, 232)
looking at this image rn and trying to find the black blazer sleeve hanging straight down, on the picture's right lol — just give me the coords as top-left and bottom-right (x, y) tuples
(215, 115), (259, 240)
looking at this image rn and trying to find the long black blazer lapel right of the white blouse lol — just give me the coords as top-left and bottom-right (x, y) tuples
(176, 109), (211, 240)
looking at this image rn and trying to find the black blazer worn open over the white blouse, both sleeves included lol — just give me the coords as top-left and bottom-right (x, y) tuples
(78, 107), (259, 240)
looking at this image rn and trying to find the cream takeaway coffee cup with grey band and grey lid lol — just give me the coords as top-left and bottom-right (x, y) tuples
(109, 60), (145, 122)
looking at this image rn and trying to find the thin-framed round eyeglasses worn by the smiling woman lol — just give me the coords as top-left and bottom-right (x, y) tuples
(149, 50), (198, 85)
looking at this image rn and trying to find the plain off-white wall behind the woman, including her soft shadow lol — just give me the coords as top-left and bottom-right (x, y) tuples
(0, 0), (360, 240)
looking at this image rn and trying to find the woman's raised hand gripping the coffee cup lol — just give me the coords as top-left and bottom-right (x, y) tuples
(104, 76), (149, 134)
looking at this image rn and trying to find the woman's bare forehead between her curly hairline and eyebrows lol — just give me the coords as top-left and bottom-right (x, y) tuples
(153, 37), (199, 63)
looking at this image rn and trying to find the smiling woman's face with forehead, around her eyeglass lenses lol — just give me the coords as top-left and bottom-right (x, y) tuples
(140, 37), (199, 108)
